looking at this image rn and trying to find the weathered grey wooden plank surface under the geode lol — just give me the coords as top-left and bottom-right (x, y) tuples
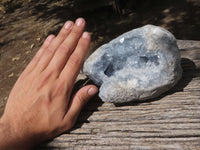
(38, 40), (200, 150)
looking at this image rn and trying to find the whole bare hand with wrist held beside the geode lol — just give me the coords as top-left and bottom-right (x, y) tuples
(0, 18), (98, 150)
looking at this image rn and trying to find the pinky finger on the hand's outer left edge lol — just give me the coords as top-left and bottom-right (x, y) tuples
(24, 35), (55, 73)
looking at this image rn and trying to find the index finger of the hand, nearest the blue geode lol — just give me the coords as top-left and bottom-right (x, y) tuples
(60, 32), (91, 86)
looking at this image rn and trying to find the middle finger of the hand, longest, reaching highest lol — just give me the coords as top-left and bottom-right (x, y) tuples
(48, 18), (85, 75)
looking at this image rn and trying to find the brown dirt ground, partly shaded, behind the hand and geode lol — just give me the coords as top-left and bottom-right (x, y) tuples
(0, 0), (200, 116)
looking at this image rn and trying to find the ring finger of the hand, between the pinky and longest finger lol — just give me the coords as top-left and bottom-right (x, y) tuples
(37, 21), (73, 71)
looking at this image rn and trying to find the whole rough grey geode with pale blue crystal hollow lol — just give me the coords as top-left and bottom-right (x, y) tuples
(83, 25), (182, 103)
